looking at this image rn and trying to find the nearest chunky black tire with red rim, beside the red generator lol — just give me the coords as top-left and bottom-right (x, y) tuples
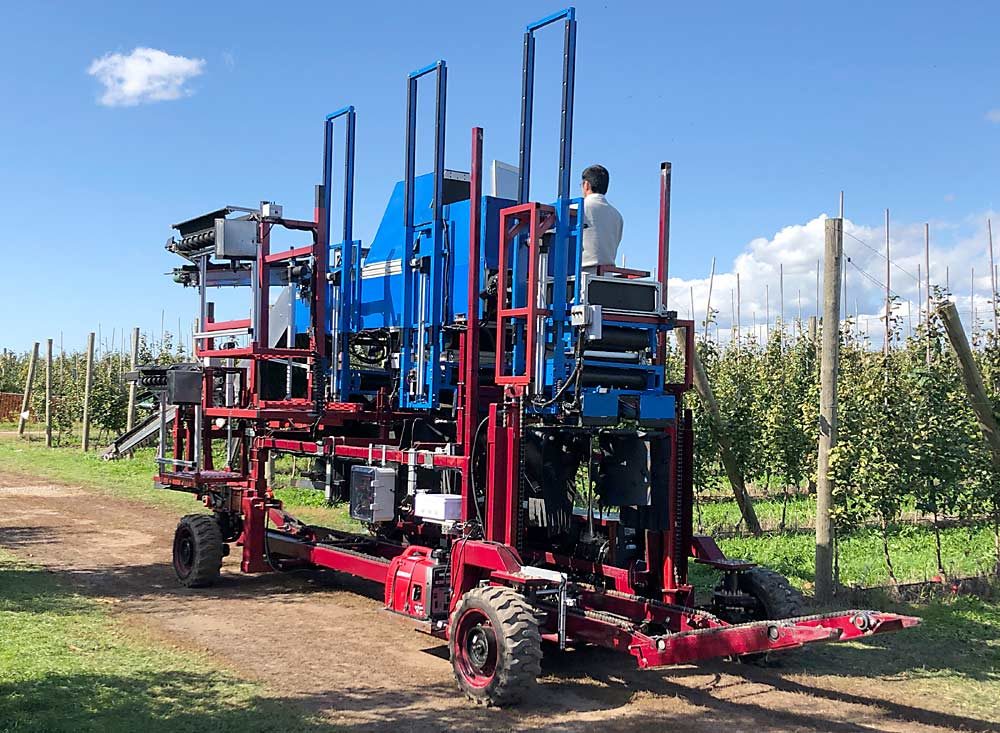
(448, 587), (542, 706)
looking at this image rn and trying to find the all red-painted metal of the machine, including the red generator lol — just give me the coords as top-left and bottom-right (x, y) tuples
(152, 123), (919, 688)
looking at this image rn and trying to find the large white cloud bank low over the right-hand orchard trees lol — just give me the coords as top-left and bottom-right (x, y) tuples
(669, 212), (1000, 341)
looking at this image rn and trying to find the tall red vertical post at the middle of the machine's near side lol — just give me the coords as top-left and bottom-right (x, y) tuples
(462, 127), (483, 520)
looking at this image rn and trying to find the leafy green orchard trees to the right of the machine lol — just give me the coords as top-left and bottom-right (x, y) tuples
(689, 294), (1000, 579)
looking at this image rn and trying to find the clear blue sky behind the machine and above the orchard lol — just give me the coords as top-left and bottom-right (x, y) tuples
(0, 1), (1000, 348)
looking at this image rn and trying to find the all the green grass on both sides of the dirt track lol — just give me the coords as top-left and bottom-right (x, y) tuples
(0, 435), (1000, 733)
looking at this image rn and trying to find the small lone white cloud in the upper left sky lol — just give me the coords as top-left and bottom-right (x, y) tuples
(87, 48), (205, 107)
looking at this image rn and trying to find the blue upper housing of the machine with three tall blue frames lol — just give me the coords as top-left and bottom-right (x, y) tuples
(308, 9), (675, 425)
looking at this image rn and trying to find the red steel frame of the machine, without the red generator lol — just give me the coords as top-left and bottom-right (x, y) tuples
(157, 128), (918, 667)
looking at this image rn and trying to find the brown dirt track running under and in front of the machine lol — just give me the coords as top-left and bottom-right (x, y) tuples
(0, 471), (1000, 733)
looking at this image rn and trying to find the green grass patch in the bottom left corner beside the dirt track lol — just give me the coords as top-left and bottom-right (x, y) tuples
(0, 552), (328, 733)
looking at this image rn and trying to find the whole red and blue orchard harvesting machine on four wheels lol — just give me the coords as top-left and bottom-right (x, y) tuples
(132, 9), (917, 704)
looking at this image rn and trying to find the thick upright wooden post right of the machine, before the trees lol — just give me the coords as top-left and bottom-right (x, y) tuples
(816, 219), (844, 603)
